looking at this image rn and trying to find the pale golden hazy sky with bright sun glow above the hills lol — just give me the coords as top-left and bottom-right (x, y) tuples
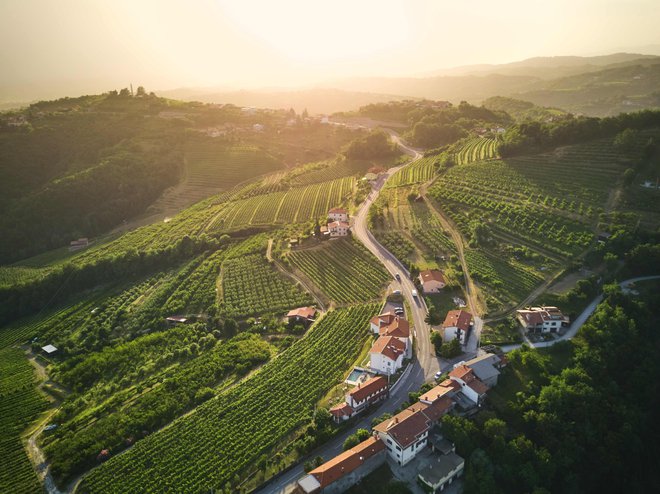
(0, 0), (660, 100)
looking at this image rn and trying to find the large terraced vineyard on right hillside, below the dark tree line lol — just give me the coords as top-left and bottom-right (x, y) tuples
(430, 141), (623, 258)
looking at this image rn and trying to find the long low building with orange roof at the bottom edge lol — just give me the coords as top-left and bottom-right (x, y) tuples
(296, 436), (385, 494)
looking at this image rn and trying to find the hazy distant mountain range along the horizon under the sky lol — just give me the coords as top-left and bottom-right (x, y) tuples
(159, 53), (660, 116)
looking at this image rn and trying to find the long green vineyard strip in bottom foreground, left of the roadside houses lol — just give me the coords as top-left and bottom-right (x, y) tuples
(80, 304), (378, 493)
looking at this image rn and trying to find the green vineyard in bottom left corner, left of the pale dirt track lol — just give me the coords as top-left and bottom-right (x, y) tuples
(0, 348), (48, 494)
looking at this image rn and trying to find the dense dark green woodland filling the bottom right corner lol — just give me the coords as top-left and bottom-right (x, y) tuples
(442, 285), (660, 494)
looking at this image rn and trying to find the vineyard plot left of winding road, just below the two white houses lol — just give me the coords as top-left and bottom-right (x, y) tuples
(287, 239), (390, 304)
